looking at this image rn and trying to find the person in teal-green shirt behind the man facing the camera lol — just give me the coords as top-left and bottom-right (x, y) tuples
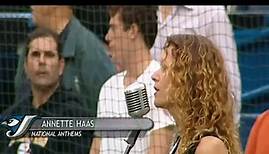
(15, 5), (115, 120)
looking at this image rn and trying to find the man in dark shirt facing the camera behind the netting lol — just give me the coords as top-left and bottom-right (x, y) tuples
(0, 28), (93, 154)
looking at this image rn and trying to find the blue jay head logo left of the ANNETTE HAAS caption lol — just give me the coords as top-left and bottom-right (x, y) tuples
(0, 115), (36, 138)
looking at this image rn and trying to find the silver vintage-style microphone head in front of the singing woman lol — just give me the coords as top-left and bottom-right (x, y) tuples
(124, 82), (150, 118)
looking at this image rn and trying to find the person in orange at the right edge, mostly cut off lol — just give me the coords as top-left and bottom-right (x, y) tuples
(246, 110), (269, 154)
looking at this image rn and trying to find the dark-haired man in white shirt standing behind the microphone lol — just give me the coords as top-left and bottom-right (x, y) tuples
(91, 6), (174, 154)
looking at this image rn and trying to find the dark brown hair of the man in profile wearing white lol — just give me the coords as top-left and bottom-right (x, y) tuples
(108, 5), (158, 49)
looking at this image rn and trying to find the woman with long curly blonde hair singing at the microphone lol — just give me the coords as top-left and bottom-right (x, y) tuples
(152, 35), (242, 154)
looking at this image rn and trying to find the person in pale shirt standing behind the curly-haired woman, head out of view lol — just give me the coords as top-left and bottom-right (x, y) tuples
(151, 5), (241, 123)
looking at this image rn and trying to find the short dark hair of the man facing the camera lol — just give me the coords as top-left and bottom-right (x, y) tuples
(25, 27), (62, 58)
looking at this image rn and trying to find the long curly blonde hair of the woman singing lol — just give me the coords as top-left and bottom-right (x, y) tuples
(162, 35), (242, 154)
